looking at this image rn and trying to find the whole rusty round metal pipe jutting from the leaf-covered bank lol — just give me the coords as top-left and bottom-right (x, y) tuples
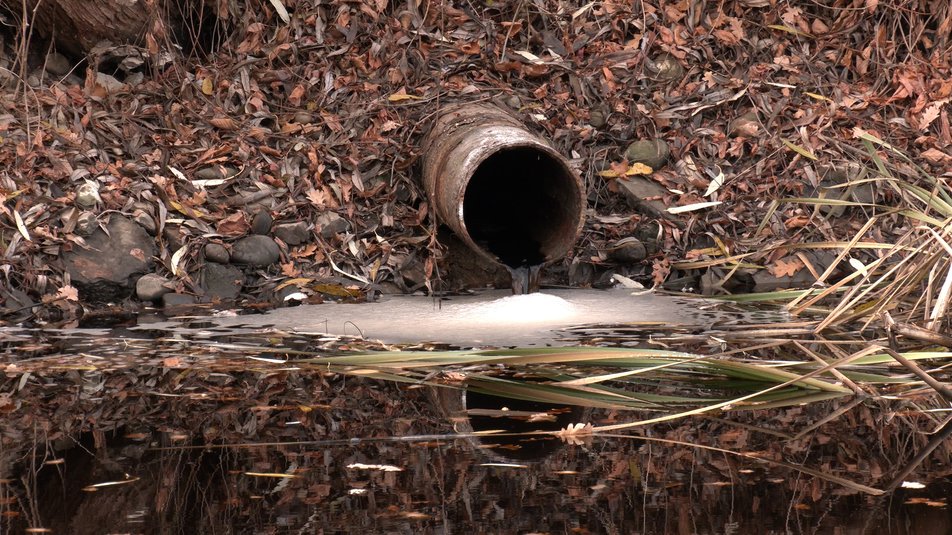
(422, 104), (585, 267)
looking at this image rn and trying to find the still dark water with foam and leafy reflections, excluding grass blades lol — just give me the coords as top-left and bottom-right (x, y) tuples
(0, 290), (952, 534)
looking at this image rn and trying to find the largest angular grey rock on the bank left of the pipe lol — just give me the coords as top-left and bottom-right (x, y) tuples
(63, 215), (155, 302)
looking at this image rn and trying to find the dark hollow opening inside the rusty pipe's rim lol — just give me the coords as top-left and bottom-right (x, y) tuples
(463, 147), (581, 267)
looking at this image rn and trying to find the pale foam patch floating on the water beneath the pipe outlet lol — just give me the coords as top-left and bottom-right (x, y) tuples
(203, 289), (788, 347)
